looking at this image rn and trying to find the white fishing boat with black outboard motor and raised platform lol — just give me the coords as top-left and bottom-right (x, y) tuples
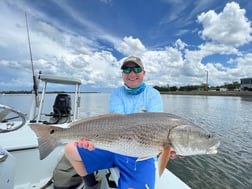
(0, 74), (190, 189)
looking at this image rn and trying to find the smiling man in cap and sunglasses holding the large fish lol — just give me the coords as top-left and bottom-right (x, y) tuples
(65, 56), (163, 189)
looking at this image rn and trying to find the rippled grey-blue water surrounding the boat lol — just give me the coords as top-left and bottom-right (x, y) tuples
(0, 93), (252, 189)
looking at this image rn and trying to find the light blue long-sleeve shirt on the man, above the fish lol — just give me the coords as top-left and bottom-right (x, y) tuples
(109, 86), (163, 114)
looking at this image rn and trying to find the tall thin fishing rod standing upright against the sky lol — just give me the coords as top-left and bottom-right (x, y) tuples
(25, 13), (39, 106)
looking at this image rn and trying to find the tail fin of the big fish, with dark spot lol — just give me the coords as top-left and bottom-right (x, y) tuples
(30, 124), (63, 160)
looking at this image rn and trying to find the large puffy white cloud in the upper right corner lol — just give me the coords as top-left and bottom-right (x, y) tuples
(198, 2), (252, 47)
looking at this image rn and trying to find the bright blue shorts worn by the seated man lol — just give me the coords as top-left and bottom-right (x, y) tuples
(77, 147), (156, 189)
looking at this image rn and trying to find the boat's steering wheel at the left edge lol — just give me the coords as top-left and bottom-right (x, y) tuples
(0, 104), (26, 133)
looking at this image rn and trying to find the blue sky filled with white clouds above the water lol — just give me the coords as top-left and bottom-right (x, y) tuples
(0, 0), (252, 92)
